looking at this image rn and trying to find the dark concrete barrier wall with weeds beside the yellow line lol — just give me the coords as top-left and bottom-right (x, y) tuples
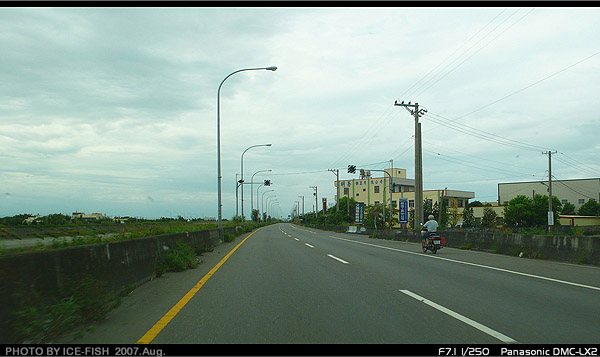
(0, 227), (235, 343)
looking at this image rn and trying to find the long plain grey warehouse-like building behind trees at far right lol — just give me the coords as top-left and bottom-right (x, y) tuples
(498, 178), (600, 210)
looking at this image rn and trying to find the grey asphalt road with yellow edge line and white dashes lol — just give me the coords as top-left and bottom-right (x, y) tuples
(74, 224), (600, 344)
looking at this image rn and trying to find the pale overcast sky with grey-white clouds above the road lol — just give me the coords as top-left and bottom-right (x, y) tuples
(0, 6), (600, 219)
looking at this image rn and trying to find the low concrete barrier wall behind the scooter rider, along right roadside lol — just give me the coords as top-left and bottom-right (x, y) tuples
(313, 226), (600, 265)
